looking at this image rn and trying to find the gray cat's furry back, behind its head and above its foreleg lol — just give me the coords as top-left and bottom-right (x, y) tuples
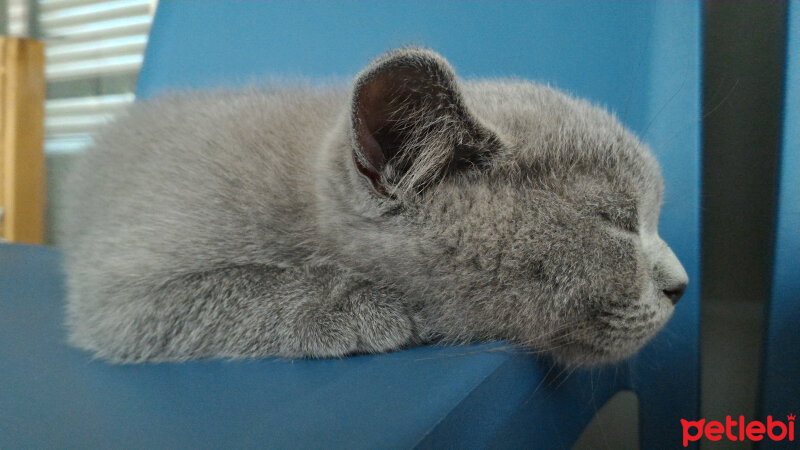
(66, 87), (346, 274)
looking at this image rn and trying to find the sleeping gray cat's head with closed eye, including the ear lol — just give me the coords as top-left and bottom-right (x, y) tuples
(323, 49), (688, 364)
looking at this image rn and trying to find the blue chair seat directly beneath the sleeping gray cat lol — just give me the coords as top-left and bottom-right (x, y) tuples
(0, 245), (628, 448)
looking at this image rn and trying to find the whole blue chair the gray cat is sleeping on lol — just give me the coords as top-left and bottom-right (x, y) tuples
(0, 0), (700, 448)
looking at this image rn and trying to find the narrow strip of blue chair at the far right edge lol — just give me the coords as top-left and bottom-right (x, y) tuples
(761, 2), (800, 447)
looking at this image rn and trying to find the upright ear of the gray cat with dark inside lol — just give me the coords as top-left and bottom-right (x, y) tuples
(351, 48), (500, 196)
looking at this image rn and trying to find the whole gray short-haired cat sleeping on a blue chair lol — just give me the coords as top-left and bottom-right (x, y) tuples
(65, 48), (688, 365)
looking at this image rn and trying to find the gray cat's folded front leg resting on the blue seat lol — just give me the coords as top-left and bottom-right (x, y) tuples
(67, 265), (417, 363)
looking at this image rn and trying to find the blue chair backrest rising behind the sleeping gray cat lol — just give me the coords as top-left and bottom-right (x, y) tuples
(138, 0), (701, 448)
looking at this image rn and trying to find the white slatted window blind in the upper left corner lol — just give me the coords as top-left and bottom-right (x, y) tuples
(27, 0), (156, 153)
